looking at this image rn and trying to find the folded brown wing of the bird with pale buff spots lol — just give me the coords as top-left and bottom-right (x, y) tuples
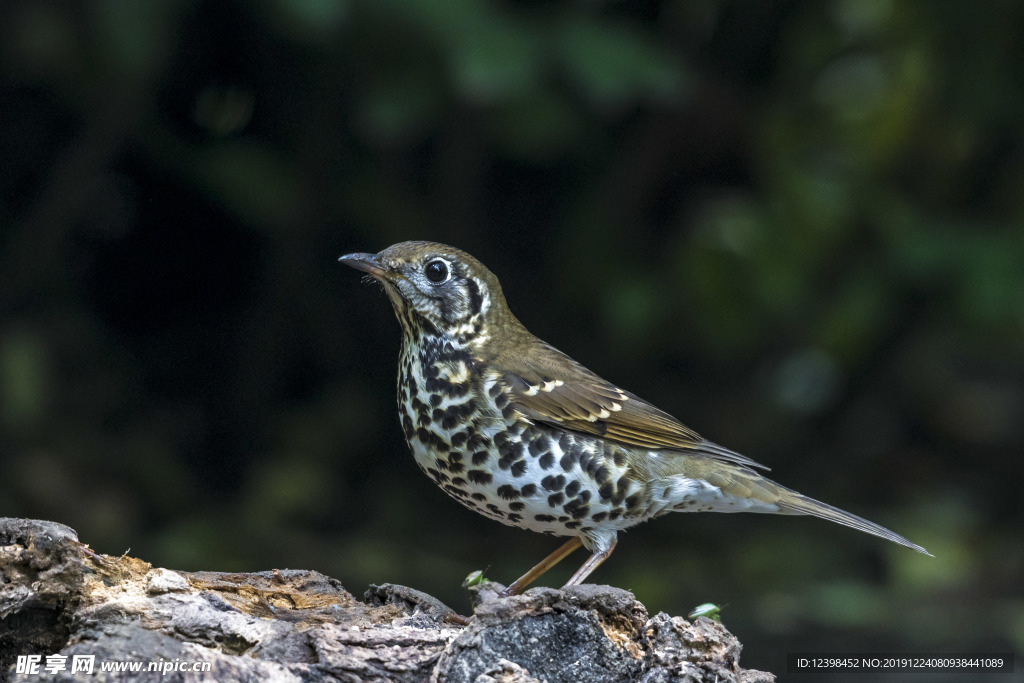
(495, 342), (768, 469)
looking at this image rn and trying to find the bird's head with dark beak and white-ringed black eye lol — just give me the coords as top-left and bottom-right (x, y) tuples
(338, 242), (511, 345)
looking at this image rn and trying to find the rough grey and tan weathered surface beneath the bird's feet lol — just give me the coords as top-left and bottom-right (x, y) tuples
(0, 519), (774, 683)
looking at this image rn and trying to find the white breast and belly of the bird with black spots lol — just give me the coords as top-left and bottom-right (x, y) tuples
(398, 335), (649, 538)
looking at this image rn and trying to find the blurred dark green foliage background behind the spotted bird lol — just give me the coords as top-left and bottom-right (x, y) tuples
(0, 0), (1024, 680)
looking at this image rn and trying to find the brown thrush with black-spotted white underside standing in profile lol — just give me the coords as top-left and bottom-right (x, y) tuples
(339, 242), (930, 596)
